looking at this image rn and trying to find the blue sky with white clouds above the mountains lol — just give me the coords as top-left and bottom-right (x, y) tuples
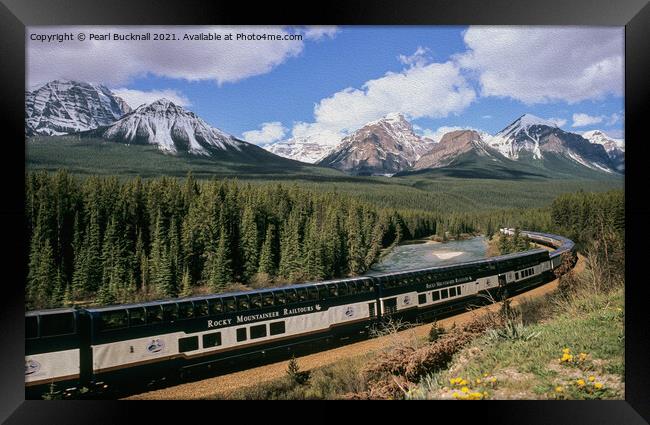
(26, 26), (624, 145)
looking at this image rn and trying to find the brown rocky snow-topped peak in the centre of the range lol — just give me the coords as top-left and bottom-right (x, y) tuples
(319, 113), (434, 175)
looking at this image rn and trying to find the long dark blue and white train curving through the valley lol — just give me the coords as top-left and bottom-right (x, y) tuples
(25, 228), (575, 399)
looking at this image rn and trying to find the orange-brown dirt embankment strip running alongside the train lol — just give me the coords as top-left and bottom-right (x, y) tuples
(127, 255), (584, 400)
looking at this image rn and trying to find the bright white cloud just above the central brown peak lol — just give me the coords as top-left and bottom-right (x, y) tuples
(293, 62), (476, 139)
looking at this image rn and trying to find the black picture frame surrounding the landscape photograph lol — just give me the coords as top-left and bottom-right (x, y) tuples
(0, 0), (650, 425)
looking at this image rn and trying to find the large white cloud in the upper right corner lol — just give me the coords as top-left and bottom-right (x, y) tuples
(455, 26), (624, 104)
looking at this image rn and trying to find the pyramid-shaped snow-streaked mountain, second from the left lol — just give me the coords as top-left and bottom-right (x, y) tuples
(84, 99), (253, 156)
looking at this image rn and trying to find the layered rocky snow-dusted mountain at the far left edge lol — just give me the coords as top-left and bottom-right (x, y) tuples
(25, 80), (131, 136)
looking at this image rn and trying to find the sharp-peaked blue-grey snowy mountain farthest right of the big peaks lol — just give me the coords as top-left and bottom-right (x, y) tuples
(486, 114), (616, 172)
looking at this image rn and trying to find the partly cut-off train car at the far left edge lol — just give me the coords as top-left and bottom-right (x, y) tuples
(25, 308), (82, 398)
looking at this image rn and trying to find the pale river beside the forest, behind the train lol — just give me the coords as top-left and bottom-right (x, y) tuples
(365, 236), (487, 275)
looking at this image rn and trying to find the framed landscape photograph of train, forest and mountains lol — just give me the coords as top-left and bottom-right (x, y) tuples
(24, 25), (625, 400)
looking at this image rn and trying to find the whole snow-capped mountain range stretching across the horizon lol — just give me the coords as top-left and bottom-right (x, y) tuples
(25, 80), (625, 176)
